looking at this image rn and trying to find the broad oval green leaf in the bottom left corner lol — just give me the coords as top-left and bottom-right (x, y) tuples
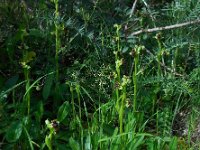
(6, 121), (23, 142)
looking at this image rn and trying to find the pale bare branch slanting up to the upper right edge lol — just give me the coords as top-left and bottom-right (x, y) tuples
(131, 19), (200, 35)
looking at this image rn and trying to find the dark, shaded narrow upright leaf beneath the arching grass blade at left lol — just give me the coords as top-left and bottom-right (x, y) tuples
(42, 74), (54, 100)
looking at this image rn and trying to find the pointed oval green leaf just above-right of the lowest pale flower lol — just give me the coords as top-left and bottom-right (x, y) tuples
(57, 101), (70, 122)
